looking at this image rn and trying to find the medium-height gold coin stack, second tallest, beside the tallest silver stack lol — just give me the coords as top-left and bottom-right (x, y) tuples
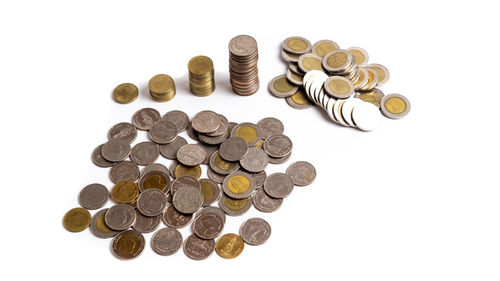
(188, 56), (215, 97)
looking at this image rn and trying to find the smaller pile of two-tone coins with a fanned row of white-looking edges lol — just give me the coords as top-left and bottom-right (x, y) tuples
(269, 36), (411, 131)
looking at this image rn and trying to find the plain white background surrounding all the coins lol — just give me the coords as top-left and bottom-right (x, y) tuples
(0, 0), (500, 280)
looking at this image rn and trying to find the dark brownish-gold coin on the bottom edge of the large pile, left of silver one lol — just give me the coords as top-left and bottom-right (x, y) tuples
(111, 230), (146, 259)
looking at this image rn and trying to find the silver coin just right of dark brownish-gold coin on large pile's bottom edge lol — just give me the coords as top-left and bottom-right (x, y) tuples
(151, 227), (186, 256)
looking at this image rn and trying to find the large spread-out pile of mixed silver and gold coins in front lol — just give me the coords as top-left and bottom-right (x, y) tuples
(63, 108), (316, 260)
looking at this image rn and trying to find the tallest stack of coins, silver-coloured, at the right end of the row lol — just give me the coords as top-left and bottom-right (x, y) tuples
(229, 35), (259, 96)
